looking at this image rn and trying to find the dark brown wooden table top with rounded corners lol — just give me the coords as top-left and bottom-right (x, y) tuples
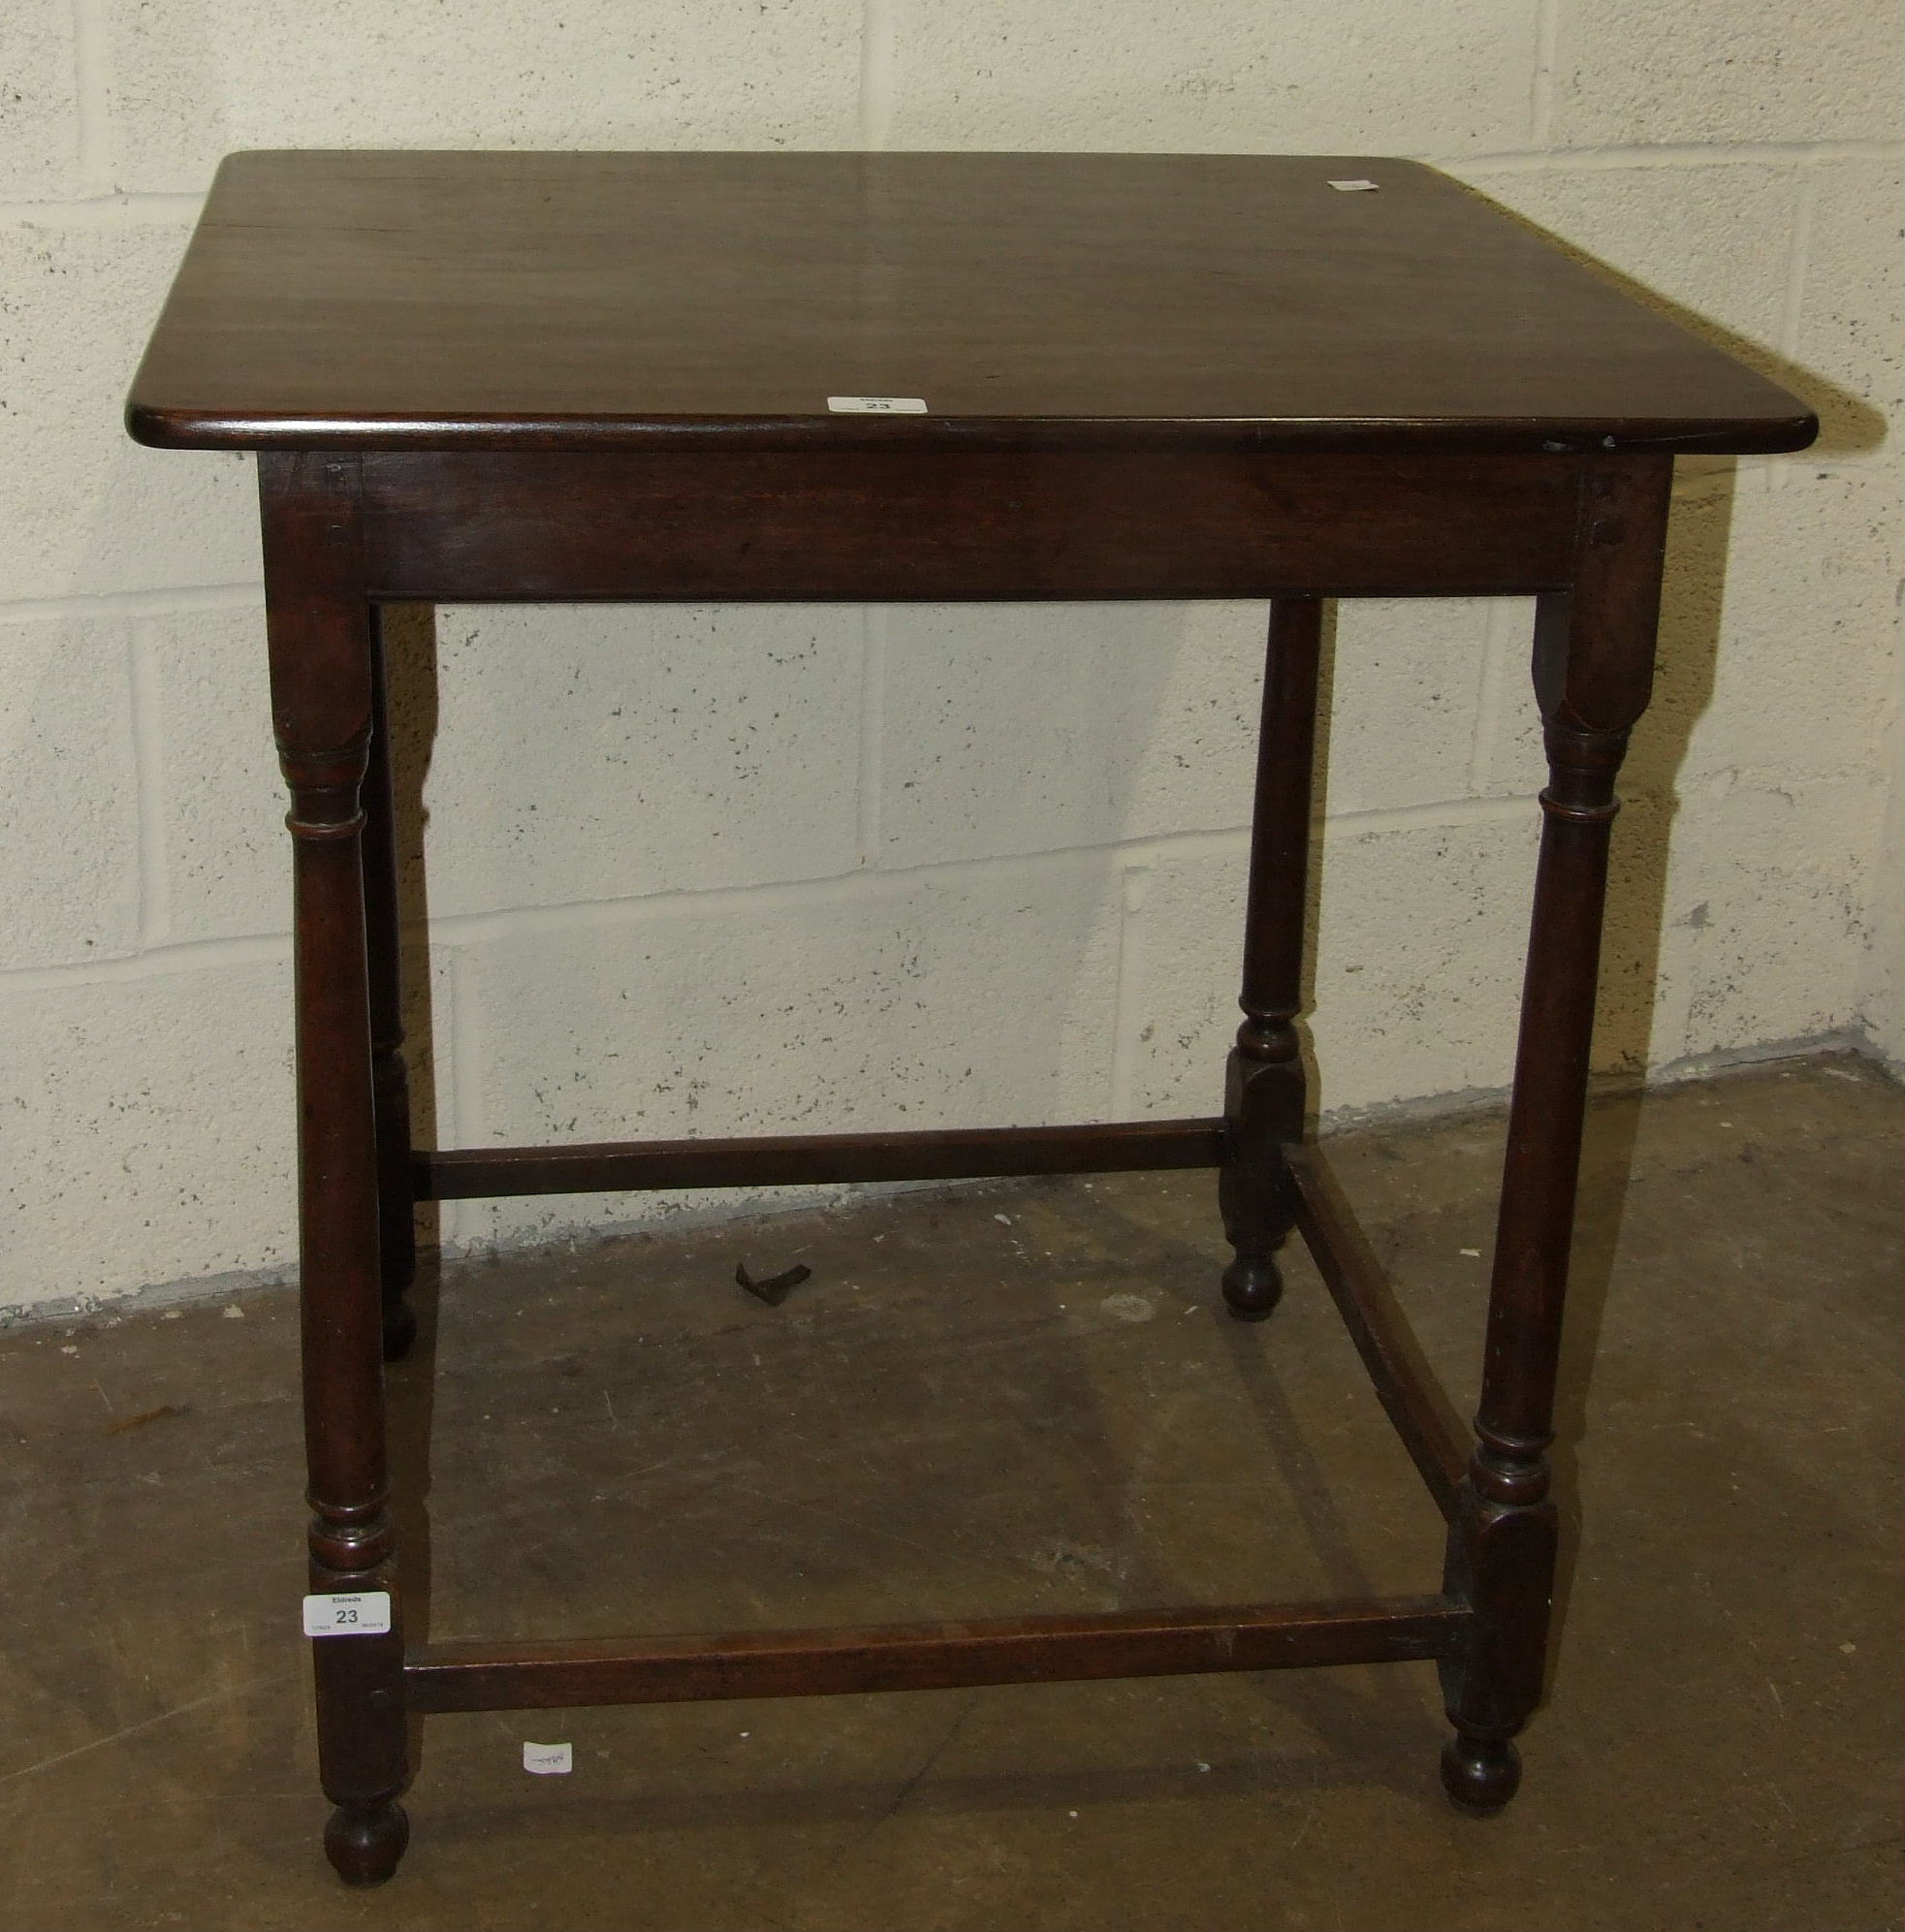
(128, 152), (1816, 452)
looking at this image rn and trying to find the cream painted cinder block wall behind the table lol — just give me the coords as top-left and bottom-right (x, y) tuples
(0, 0), (1905, 1310)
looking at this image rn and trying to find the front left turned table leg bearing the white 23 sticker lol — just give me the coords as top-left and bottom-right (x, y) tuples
(259, 454), (409, 1885)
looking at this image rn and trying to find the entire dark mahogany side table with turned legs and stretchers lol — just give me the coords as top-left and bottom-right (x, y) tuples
(128, 152), (1816, 1884)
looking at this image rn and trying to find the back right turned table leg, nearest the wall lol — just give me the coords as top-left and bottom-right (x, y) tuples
(1218, 597), (1323, 1321)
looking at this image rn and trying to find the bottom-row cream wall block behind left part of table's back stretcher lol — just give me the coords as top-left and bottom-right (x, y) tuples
(456, 854), (1123, 1235)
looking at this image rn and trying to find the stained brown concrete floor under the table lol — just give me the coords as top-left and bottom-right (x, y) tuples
(0, 1061), (1905, 1932)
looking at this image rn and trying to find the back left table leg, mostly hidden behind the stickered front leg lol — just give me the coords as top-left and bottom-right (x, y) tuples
(362, 611), (417, 1362)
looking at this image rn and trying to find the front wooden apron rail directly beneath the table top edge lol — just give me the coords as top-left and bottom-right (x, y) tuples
(360, 448), (1584, 603)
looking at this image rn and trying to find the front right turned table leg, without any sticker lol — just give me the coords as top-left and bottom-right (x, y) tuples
(1442, 458), (1671, 1816)
